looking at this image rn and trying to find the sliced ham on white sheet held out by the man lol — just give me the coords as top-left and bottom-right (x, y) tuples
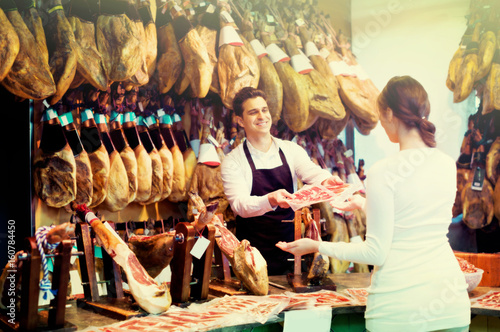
(288, 183), (363, 211)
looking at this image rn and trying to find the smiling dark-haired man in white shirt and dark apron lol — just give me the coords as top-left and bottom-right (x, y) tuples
(221, 87), (342, 275)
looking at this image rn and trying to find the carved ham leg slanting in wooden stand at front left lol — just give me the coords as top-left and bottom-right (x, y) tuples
(72, 204), (172, 314)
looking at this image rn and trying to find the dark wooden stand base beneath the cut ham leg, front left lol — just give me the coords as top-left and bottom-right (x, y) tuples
(77, 297), (147, 320)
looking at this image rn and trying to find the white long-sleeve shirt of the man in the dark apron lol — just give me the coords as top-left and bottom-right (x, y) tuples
(221, 137), (331, 218)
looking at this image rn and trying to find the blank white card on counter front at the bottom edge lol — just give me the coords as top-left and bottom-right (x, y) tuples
(283, 308), (332, 332)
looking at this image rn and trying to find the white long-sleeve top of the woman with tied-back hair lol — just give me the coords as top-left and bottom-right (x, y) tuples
(319, 148), (470, 332)
